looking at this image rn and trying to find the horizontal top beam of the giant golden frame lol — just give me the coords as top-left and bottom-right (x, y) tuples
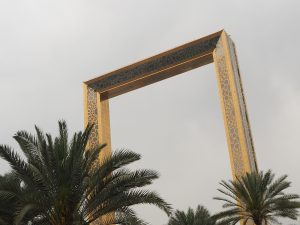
(85, 30), (224, 98)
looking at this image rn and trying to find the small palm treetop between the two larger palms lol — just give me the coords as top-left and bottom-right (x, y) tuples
(168, 205), (215, 225)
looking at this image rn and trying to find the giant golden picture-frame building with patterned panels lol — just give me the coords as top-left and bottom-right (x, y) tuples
(83, 30), (257, 177)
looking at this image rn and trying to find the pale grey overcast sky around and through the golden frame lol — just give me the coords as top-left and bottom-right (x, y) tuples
(0, 0), (300, 225)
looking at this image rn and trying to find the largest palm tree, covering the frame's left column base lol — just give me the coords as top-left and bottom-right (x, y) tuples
(0, 121), (171, 225)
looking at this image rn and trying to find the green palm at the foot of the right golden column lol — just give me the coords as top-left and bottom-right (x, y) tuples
(213, 170), (300, 225)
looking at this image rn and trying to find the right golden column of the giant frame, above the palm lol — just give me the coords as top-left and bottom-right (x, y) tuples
(213, 32), (257, 177)
